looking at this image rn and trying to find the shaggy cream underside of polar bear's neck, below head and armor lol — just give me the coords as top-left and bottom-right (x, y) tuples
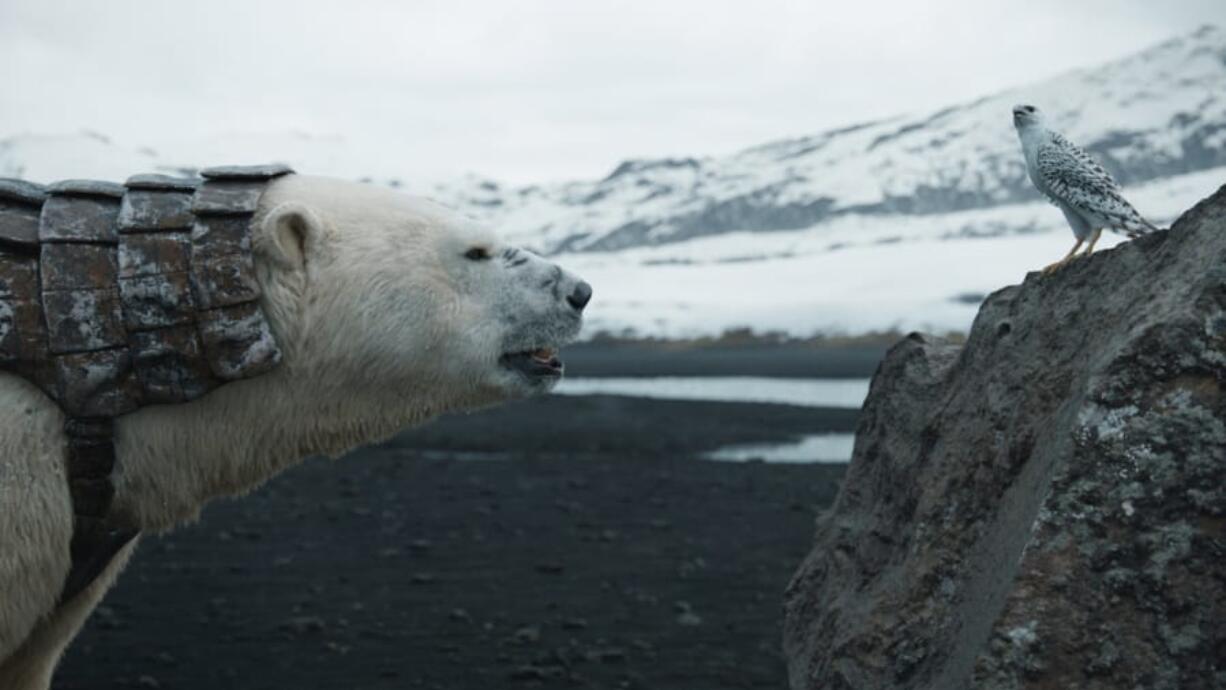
(115, 370), (436, 531)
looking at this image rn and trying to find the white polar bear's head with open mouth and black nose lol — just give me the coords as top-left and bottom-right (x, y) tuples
(253, 175), (592, 422)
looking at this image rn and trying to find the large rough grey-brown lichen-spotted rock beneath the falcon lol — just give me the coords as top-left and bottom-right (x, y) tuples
(783, 188), (1226, 690)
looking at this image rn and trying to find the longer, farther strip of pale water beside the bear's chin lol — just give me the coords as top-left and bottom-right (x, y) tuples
(554, 376), (868, 409)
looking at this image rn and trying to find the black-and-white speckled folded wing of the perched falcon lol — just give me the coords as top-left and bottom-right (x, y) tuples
(1035, 132), (1156, 234)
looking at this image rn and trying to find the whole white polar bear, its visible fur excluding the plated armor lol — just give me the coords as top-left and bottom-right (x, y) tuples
(0, 175), (591, 690)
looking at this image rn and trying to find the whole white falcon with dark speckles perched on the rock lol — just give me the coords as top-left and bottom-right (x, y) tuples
(1013, 105), (1159, 273)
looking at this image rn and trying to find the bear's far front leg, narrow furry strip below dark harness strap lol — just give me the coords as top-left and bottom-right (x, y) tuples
(0, 538), (139, 690)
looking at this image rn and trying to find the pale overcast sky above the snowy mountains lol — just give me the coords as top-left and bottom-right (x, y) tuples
(0, 0), (1226, 183)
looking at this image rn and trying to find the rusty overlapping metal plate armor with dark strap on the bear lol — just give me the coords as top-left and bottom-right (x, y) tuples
(0, 165), (292, 601)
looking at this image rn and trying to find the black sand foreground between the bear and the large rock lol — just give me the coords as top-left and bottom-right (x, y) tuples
(54, 343), (875, 690)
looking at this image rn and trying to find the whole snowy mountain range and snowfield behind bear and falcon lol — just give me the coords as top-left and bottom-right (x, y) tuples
(0, 27), (1226, 337)
